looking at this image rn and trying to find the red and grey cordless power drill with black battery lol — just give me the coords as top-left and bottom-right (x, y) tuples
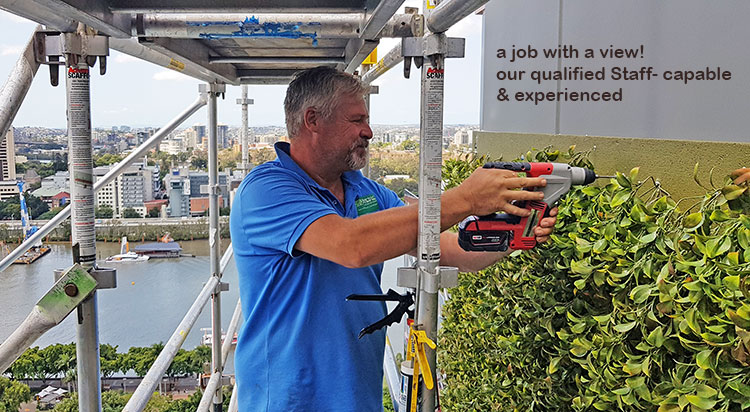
(458, 162), (612, 252)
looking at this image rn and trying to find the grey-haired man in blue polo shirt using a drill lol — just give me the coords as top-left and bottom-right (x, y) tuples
(230, 67), (556, 412)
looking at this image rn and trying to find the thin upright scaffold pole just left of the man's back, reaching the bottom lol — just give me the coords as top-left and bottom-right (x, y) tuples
(208, 83), (225, 412)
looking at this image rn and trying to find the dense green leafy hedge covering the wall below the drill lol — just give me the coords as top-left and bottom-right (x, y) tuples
(438, 148), (750, 412)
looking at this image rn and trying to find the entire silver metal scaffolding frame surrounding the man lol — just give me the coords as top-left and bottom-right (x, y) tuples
(0, 0), (488, 412)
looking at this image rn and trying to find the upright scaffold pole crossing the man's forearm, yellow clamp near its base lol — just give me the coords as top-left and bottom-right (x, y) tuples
(389, 2), (464, 412)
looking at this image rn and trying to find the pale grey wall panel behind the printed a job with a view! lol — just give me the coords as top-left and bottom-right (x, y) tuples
(480, 0), (750, 142)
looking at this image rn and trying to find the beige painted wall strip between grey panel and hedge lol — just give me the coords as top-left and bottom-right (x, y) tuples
(475, 132), (750, 199)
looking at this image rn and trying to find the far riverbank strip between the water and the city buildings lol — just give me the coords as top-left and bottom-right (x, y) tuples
(0, 216), (229, 244)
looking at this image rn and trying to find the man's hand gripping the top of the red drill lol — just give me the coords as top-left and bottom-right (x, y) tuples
(455, 168), (547, 216)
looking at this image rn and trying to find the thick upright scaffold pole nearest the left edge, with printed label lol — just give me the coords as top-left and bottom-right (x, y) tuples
(65, 54), (102, 412)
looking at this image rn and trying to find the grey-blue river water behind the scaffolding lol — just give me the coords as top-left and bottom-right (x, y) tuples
(0, 240), (412, 352)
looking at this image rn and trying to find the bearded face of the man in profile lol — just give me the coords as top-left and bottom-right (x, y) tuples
(323, 96), (372, 170)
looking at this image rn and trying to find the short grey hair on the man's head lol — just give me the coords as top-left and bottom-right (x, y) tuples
(284, 66), (368, 139)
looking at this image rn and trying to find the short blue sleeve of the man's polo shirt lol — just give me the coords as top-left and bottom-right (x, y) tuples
(237, 168), (336, 256)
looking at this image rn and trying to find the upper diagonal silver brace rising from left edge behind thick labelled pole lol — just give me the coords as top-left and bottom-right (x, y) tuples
(0, 94), (207, 272)
